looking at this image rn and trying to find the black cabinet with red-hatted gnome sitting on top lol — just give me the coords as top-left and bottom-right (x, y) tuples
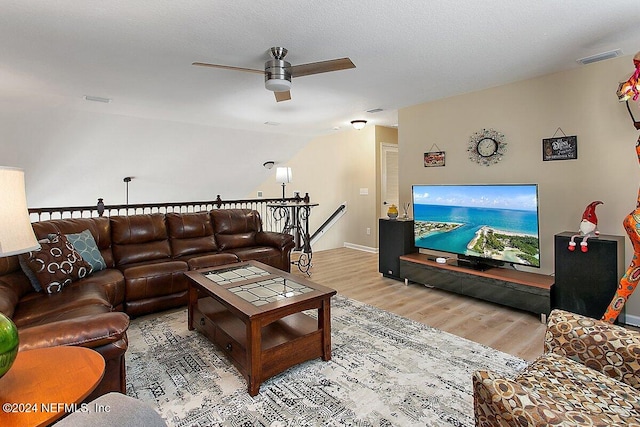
(551, 231), (625, 319)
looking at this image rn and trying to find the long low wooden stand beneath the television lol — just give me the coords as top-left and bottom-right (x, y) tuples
(400, 253), (554, 322)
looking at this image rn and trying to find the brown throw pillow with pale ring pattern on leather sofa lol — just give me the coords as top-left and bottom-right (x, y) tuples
(27, 234), (91, 294)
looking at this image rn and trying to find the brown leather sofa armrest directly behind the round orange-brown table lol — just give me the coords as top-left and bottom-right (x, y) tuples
(18, 312), (129, 351)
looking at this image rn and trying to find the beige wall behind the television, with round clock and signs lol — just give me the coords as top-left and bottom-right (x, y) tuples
(399, 57), (640, 316)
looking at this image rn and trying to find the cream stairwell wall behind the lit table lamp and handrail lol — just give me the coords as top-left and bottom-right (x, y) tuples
(250, 126), (377, 251)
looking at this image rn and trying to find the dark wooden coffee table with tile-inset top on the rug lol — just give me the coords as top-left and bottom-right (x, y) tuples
(185, 261), (336, 396)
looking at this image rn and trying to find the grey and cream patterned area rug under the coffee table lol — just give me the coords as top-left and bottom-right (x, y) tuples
(126, 295), (526, 427)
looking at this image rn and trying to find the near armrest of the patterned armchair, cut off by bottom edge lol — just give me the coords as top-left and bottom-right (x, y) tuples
(472, 371), (580, 427)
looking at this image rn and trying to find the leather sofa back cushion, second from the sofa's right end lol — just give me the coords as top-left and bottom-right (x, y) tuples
(166, 212), (218, 258)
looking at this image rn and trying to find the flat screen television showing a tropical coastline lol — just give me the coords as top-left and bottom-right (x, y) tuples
(412, 184), (540, 269)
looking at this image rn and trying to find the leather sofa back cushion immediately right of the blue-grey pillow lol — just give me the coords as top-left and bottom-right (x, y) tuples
(110, 213), (171, 266)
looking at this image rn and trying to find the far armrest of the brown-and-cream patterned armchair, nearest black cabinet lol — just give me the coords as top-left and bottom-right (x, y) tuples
(544, 309), (640, 390)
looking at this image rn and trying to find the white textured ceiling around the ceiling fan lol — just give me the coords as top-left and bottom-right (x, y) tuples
(0, 0), (640, 135)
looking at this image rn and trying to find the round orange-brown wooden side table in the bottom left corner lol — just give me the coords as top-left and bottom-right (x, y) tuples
(0, 346), (105, 427)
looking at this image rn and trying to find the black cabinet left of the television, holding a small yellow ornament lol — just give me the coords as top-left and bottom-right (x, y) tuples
(378, 218), (416, 280)
